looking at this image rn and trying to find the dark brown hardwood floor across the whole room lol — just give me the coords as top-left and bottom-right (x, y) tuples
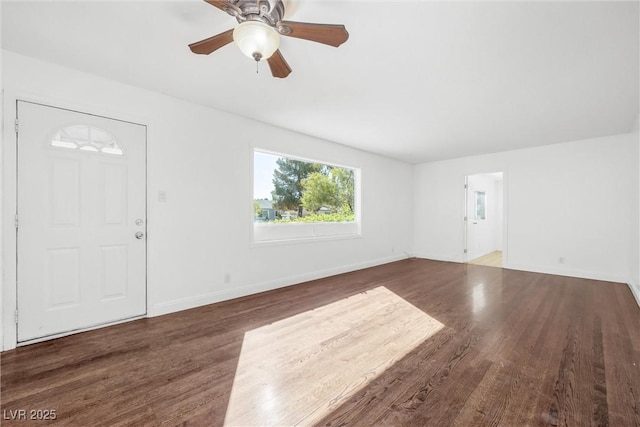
(0, 260), (640, 426)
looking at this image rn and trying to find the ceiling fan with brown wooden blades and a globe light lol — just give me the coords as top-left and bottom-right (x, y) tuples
(189, 0), (349, 78)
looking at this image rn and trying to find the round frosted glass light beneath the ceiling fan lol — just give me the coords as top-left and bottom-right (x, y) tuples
(233, 21), (280, 61)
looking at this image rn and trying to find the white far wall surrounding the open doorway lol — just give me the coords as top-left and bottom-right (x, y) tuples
(414, 134), (638, 283)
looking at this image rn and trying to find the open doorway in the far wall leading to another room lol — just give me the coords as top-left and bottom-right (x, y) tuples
(464, 172), (504, 268)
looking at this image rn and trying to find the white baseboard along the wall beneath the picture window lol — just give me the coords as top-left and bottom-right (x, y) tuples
(149, 255), (407, 317)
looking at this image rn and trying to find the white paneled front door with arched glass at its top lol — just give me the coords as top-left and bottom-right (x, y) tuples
(17, 101), (146, 342)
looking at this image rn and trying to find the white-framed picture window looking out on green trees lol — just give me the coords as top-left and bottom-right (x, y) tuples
(253, 150), (360, 243)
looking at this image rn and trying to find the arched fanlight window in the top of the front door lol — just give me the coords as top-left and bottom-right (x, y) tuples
(51, 125), (124, 156)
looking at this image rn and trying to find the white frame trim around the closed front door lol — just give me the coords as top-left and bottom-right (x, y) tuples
(0, 97), (151, 351)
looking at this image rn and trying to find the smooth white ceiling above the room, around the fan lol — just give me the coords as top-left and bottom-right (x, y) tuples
(2, 0), (640, 163)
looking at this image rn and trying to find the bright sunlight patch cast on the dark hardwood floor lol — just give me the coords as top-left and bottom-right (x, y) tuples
(225, 287), (444, 426)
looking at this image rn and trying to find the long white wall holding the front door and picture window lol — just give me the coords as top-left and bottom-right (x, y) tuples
(0, 51), (413, 349)
